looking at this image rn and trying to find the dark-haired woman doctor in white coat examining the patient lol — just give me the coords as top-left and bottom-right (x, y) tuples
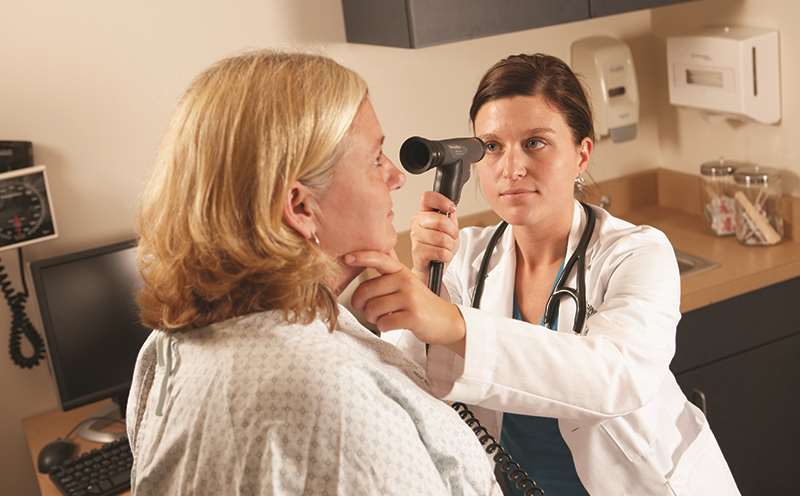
(347, 54), (739, 496)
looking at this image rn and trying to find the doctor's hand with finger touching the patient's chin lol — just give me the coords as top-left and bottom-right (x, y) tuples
(344, 251), (466, 348)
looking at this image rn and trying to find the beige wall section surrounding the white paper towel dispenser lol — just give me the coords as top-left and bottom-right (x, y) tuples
(652, 0), (800, 196)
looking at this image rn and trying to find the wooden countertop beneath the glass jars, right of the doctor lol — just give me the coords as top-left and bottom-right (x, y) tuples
(618, 205), (800, 312)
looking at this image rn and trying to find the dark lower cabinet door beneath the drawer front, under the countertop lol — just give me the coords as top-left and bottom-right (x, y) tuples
(677, 329), (800, 496)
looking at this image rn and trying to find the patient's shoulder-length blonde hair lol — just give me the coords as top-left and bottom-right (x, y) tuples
(138, 51), (367, 330)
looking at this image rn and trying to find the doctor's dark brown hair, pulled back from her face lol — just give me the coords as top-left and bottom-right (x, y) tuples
(469, 53), (594, 145)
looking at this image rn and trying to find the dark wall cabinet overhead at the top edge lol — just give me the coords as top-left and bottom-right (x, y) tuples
(342, 0), (690, 48)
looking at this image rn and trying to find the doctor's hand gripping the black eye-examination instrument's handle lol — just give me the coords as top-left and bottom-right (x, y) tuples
(410, 191), (458, 283)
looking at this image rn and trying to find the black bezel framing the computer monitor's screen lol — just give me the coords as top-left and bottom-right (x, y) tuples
(30, 239), (144, 411)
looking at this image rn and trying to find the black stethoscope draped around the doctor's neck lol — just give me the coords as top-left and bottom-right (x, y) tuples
(472, 202), (596, 334)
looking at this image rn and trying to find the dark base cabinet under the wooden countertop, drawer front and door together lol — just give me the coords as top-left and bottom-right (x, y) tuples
(671, 278), (800, 496)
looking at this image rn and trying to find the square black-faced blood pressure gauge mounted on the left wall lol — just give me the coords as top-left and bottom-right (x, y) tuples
(0, 165), (57, 250)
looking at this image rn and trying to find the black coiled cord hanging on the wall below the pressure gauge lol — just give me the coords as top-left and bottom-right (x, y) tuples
(0, 249), (45, 369)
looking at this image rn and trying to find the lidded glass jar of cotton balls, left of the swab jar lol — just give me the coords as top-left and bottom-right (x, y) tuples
(700, 157), (752, 236)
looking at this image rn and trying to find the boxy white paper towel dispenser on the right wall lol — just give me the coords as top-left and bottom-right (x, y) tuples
(667, 27), (781, 124)
